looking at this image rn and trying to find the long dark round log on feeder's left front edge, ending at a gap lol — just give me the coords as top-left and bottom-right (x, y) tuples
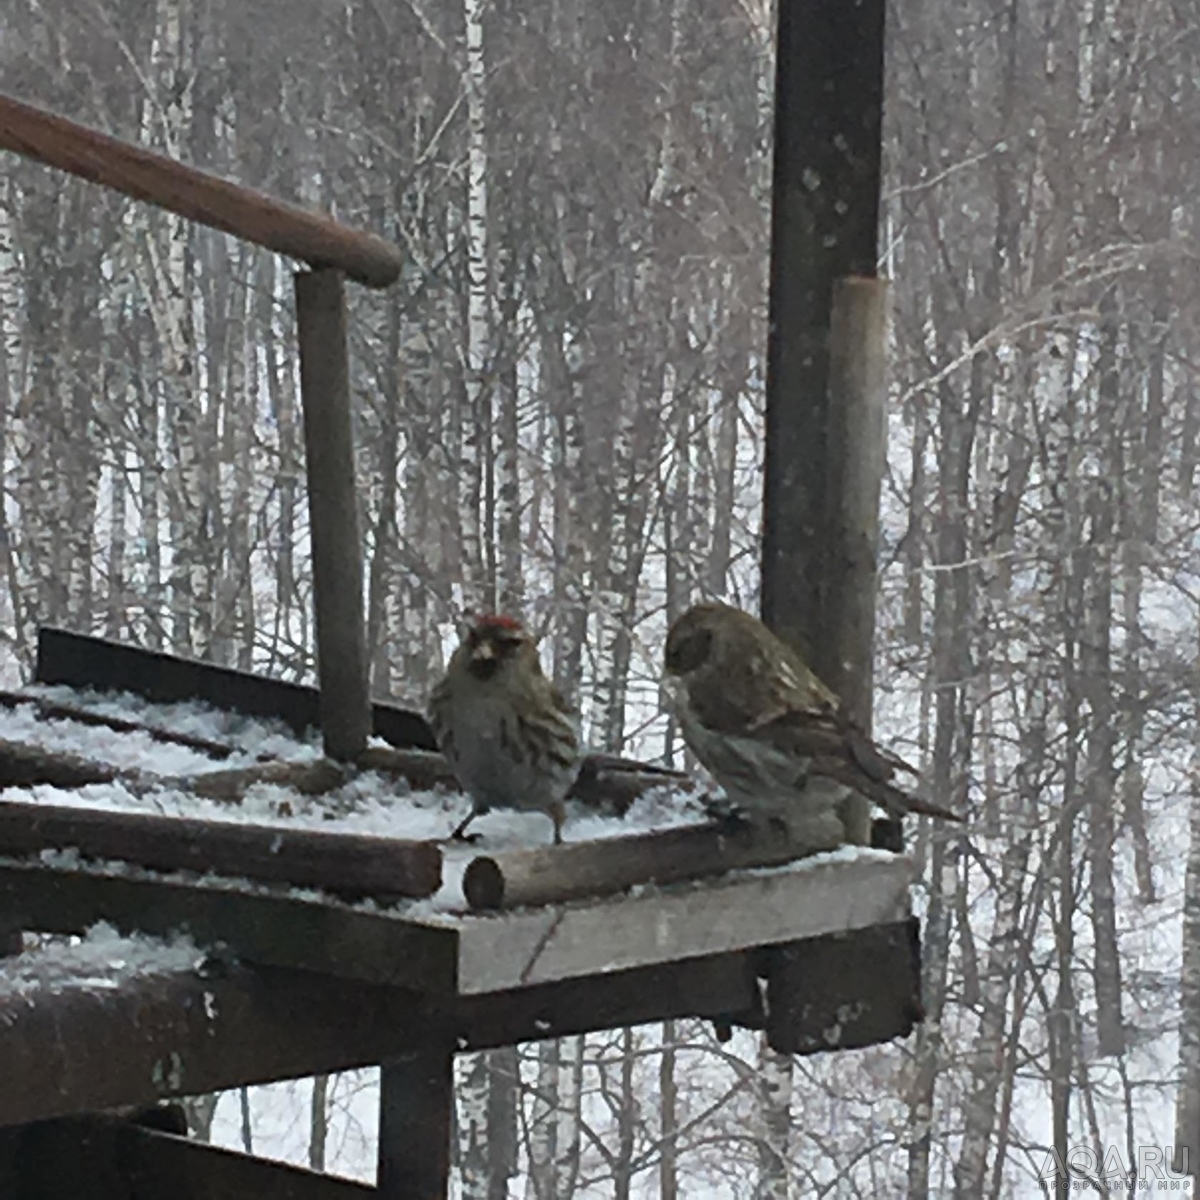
(0, 800), (442, 899)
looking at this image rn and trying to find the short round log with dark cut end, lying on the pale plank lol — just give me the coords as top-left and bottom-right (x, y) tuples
(462, 824), (825, 912)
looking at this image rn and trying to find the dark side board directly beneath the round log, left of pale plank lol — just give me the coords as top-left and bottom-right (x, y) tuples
(0, 860), (456, 994)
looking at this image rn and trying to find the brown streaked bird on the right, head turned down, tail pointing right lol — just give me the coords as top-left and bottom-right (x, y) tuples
(665, 602), (961, 850)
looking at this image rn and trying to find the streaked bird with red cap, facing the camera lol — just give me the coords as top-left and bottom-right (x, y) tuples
(428, 616), (580, 844)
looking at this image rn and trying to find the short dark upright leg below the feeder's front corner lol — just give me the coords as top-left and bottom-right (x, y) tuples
(376, 1045), (454, 1200)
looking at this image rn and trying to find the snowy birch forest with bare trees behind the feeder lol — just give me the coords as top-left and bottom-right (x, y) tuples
(0, 0), (1200, 1200)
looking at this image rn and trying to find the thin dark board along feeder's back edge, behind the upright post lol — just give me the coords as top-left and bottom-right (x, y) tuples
(34, 625), (438, 751)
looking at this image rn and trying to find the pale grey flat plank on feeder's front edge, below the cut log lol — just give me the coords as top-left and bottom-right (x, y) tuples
(455, 848), (913, 995)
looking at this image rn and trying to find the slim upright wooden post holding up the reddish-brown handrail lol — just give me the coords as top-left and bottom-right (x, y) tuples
(295, 269), (371, 762)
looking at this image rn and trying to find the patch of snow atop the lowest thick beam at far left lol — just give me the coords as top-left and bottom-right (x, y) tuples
(0, 922), (204, 1002)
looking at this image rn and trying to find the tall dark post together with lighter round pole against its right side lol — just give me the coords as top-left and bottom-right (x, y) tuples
(762, 0), (896, 848)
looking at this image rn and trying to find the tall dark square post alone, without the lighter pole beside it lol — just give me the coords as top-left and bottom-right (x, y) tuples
(762, 0), (884, 686)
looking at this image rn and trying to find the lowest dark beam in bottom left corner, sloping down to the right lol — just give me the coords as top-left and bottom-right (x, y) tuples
(0, 1115), (376, 1200)
